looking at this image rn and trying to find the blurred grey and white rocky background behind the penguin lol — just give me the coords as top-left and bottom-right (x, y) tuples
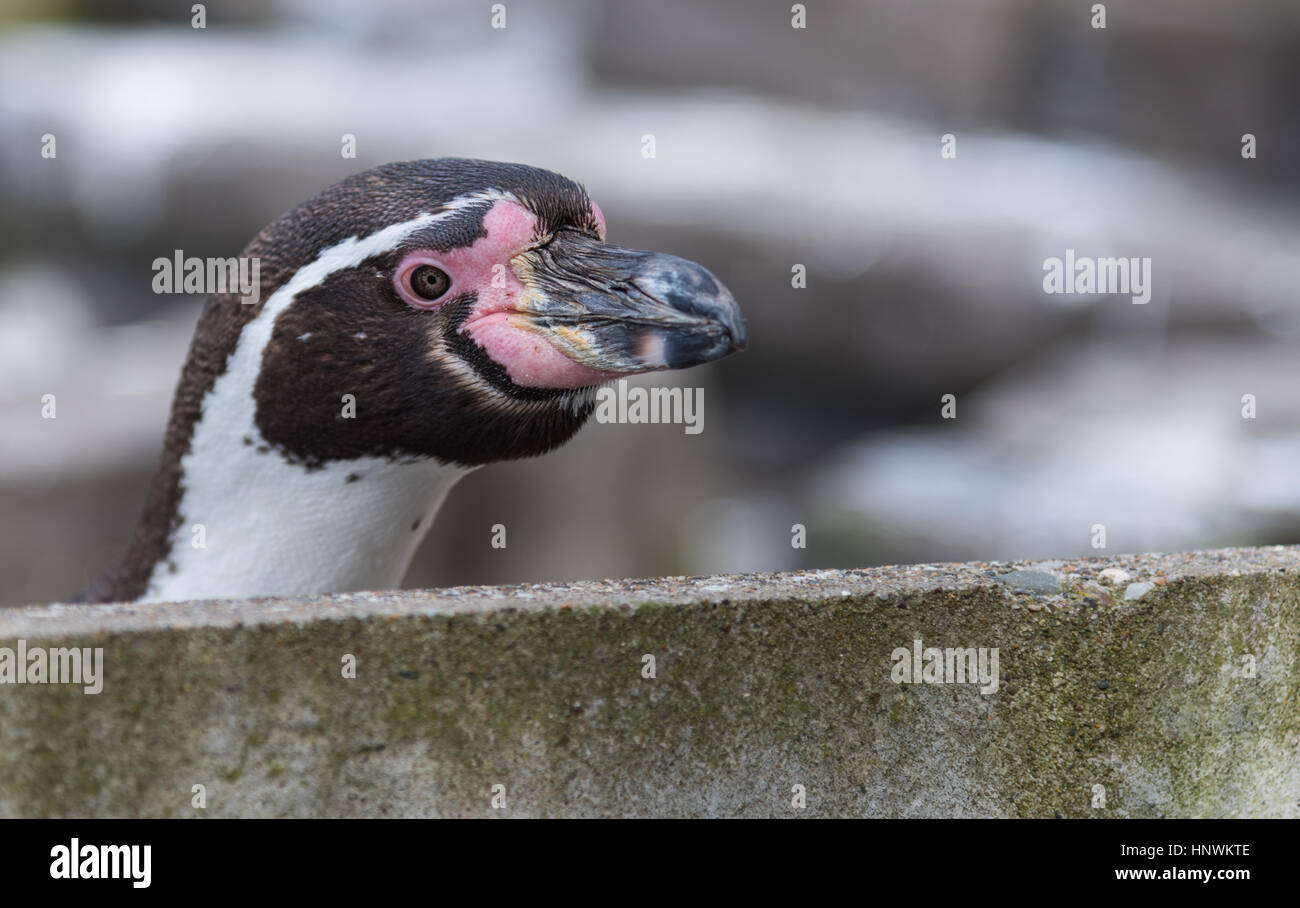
(0, 0), (1300, 605)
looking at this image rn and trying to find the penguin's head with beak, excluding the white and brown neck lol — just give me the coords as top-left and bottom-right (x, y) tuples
(244, 159), (746, 466)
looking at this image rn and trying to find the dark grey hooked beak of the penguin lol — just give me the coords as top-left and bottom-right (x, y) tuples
(511, 230), (748, 373)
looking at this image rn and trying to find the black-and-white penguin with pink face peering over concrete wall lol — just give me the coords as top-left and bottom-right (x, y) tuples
(82, 159), (746, 602)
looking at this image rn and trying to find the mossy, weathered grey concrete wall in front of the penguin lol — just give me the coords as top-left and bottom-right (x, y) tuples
(0, 546), (1300, 817)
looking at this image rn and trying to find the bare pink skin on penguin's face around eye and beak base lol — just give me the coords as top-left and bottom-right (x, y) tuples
(393, 200), (625, 389)
